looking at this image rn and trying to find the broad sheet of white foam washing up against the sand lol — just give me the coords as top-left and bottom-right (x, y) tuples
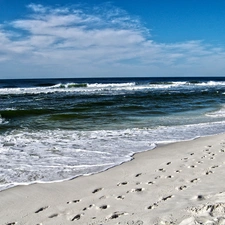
(0, 119), (225, 188)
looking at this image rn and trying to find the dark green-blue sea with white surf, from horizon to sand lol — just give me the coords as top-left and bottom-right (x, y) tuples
(0, 77), (225, 191)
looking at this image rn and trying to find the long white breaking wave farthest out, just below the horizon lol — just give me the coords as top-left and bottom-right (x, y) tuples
(0, 81), (225, 95)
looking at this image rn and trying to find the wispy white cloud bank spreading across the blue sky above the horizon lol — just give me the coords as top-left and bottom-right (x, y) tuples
(0, 4), (225, 78)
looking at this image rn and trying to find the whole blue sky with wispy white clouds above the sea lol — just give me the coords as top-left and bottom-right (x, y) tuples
(0, 0), (225, 79)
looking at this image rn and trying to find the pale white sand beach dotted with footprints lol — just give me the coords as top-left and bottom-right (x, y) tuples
(0, 134), (225, 225)
